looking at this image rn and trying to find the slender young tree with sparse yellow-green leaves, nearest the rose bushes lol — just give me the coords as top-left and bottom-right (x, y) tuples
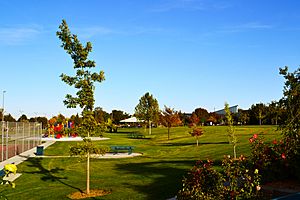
(224, 103), (237, 159)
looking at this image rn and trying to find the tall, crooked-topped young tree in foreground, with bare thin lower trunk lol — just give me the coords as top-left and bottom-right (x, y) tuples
(56, 20), (105, 194)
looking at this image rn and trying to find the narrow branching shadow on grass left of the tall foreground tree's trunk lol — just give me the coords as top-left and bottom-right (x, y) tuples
(22, 156), (83, 192)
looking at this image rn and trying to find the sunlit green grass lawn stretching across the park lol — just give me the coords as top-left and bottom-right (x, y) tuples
(2, 126), (281, 200)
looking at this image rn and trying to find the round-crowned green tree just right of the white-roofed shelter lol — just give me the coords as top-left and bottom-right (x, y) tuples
(134, 92), (159, 135)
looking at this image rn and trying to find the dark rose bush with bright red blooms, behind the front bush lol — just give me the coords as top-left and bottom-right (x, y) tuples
(249, 134), (289, 181)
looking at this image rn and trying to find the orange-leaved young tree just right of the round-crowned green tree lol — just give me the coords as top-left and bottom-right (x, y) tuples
(160, 106), (181, 140)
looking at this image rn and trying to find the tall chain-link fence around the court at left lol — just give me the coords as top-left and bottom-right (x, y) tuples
(0, 122), (42, 161)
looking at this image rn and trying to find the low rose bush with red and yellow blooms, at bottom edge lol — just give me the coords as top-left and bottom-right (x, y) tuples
(177, 156), (261, 200)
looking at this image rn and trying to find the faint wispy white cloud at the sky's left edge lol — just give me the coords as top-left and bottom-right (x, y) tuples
(0, 25), (41, 45)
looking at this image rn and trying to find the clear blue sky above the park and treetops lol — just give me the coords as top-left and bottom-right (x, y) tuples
(0, 0), (300, 118)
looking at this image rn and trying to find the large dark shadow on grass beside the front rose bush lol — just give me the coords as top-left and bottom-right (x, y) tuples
(116, 160), (195, 200)
